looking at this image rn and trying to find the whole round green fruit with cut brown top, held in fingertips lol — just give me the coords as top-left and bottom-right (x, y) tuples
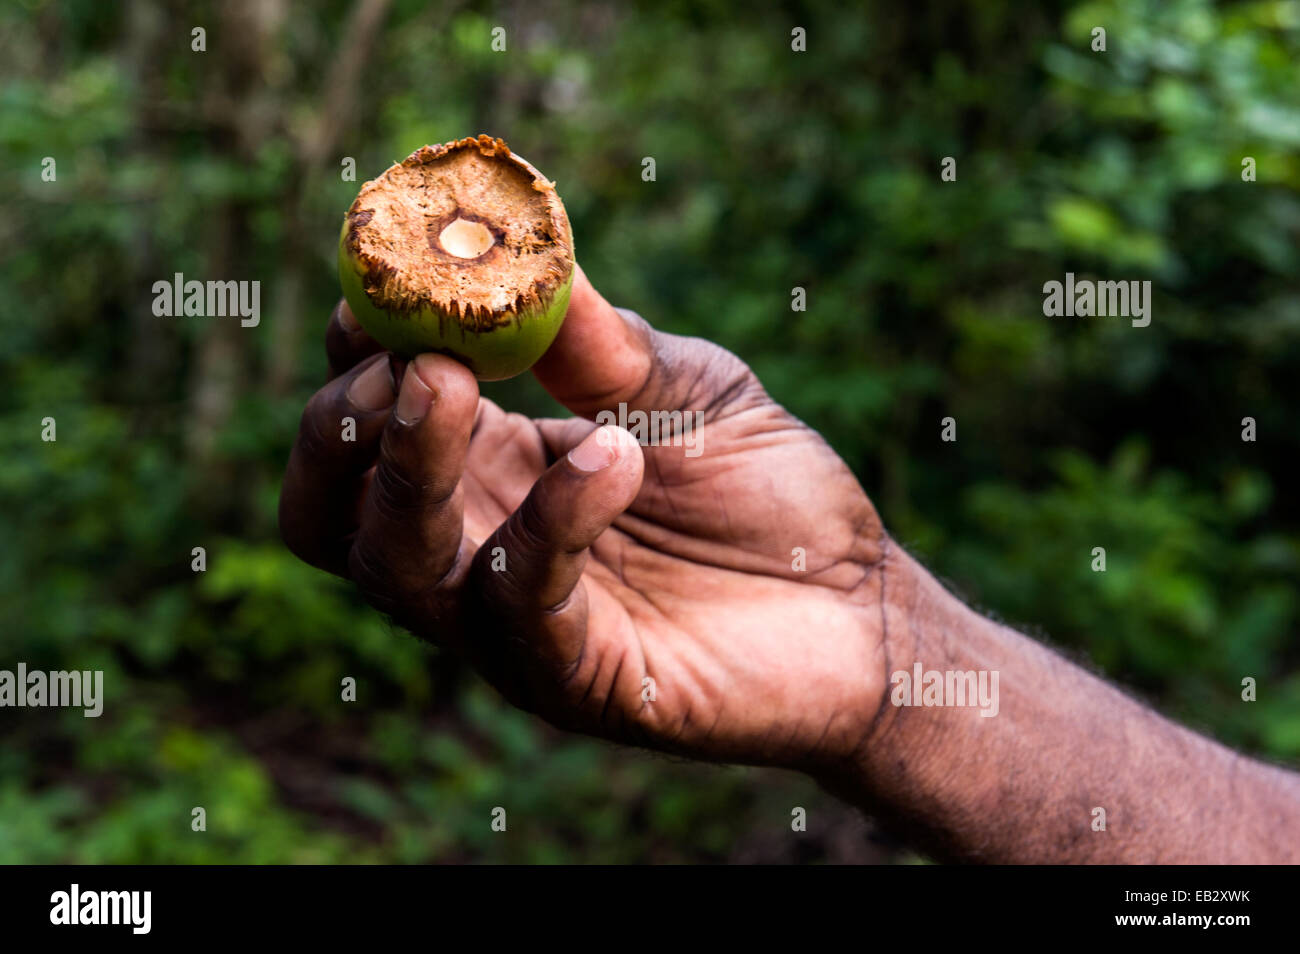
(338, 135), (573, 381)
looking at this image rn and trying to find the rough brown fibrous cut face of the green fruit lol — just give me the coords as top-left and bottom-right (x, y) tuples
(346, 136), (573, 329)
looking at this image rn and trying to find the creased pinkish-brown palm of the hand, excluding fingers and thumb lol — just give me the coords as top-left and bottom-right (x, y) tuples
(462, 400), (880, 762)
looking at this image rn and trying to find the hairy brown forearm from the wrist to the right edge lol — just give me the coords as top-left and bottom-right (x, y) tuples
(826, 547), (1300, 863)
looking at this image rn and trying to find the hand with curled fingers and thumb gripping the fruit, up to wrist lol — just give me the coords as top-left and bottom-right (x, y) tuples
(281, 270), (887, 771)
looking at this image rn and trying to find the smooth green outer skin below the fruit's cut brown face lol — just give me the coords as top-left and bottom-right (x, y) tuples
(338, 217), (573, 381)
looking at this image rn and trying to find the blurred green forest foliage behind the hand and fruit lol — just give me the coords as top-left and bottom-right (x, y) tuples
(0, 0), (1300, 863)
